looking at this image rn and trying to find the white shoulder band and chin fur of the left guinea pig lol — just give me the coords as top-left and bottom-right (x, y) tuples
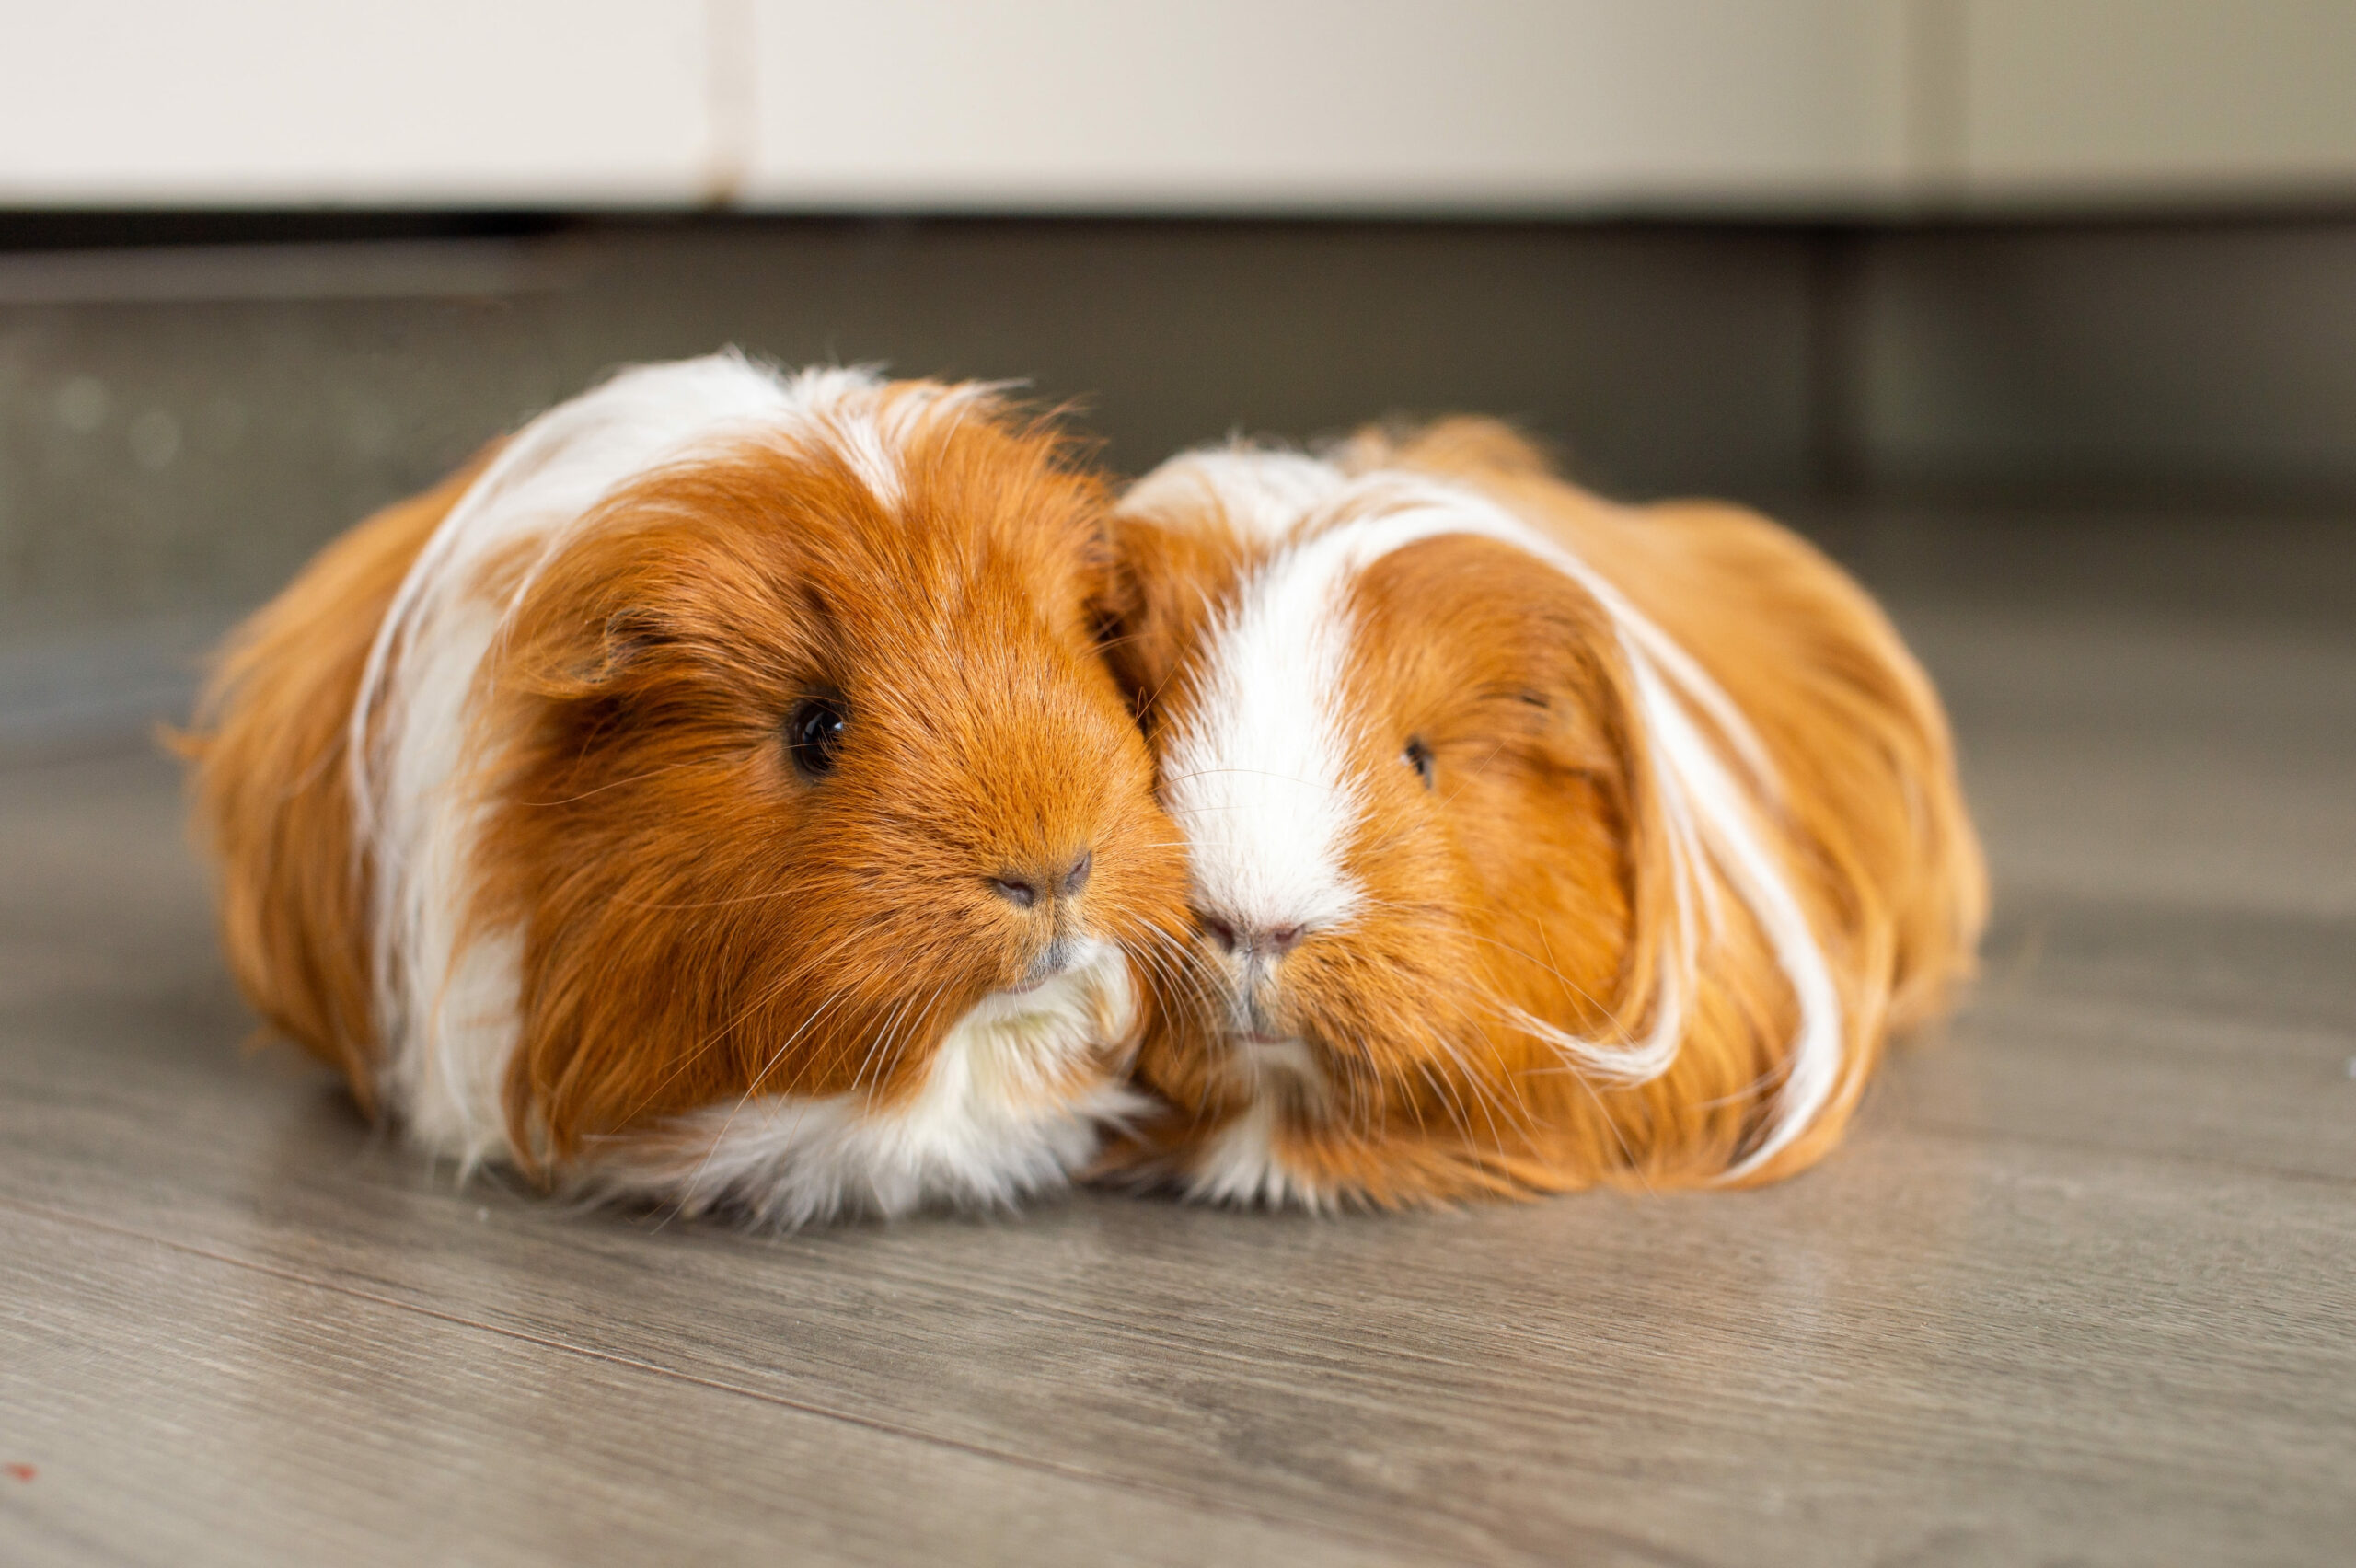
(349, 353), (1136, 1222)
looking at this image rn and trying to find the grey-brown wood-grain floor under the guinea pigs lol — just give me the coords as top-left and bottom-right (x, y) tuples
(0, 515), (2356, 1565)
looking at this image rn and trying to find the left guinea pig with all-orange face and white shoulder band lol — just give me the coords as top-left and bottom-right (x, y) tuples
(189, 355), (1185, 1224)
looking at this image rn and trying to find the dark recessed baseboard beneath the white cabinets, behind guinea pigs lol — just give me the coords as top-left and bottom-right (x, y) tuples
(0, 212), (2356, 650)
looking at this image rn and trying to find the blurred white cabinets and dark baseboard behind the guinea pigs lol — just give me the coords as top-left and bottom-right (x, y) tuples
(0, 0), (2356, 746)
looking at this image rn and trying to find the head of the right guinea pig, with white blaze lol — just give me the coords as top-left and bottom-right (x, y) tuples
(1114, 452), (1734, 1205)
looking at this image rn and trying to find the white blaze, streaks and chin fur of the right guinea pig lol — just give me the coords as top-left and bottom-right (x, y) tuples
(1122, 447), (1842, 1201)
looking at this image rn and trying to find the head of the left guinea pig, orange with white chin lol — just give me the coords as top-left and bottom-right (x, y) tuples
(375, 376), (1185, 1222)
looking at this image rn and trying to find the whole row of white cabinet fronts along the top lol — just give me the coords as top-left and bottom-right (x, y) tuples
(0, 0), (2356, 216)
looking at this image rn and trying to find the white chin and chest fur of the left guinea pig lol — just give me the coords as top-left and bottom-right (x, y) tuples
(586, 944), (1145, 1229)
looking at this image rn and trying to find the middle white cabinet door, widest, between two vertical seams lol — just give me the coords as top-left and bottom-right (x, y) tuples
(745, 0), (1906, 212)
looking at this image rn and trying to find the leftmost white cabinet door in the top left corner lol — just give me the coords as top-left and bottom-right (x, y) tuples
(0, 0), (716, 205)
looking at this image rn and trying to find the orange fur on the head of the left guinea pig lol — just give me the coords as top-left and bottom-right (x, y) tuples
(476, 409), (1183, 1160)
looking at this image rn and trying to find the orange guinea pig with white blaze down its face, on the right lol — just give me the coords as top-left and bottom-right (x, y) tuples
(1112, 419), (1986, 1208)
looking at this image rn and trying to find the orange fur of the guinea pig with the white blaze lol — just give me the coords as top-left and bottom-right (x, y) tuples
(1114, 419), (1986, 1205)
